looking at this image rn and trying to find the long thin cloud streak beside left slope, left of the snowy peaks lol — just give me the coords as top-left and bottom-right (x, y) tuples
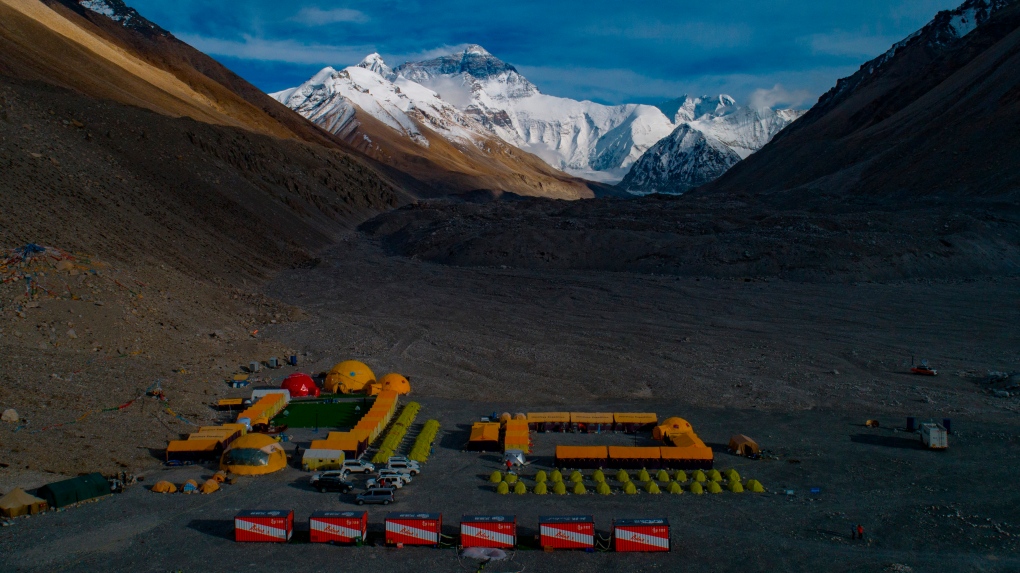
(177, 34), (376, 66)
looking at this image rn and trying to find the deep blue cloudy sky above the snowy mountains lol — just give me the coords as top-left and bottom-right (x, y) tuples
(128, 0), (963, 107)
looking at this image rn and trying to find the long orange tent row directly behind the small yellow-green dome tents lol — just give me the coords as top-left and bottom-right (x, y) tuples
(556, 446), (713, 469)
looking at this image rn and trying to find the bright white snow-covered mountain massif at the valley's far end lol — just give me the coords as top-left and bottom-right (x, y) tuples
(271, 45), (796, 187)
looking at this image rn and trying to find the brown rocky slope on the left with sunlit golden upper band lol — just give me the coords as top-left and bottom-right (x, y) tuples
(0, 0), (408, 477)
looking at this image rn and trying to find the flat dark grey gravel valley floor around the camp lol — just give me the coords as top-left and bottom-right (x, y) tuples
(0, 234), (1020, 571)
